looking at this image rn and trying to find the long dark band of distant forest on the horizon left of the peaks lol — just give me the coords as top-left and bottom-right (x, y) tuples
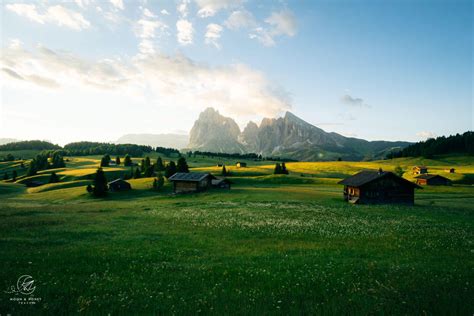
(64, 142), (153, 157)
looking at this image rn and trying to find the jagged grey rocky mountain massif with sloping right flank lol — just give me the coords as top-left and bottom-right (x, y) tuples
(187, 108), (410, 161)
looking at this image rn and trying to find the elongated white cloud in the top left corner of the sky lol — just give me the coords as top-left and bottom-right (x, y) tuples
(6, 3), (90, 31)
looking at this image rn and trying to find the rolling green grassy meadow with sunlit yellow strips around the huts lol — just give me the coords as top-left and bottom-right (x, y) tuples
(0, 156), (474, 315)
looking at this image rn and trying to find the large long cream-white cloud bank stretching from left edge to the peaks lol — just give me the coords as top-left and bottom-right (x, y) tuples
(0, 46), (291, 117)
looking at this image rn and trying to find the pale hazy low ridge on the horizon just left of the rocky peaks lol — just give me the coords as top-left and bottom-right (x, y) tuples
(115, 134), (189, 149)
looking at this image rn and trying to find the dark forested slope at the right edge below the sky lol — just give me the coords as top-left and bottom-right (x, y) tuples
(387, 132), (474, 159)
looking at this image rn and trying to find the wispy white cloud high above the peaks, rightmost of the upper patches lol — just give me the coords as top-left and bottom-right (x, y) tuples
(249, 9), (297, 46)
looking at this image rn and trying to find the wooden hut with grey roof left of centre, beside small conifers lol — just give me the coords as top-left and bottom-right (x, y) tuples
(168, 172), (216, 193)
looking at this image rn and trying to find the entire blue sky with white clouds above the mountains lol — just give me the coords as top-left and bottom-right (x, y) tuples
(0, 0), (474, 144)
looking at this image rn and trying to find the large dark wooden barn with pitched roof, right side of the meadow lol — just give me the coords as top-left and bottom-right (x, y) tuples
(338, 169), (420, 205)
